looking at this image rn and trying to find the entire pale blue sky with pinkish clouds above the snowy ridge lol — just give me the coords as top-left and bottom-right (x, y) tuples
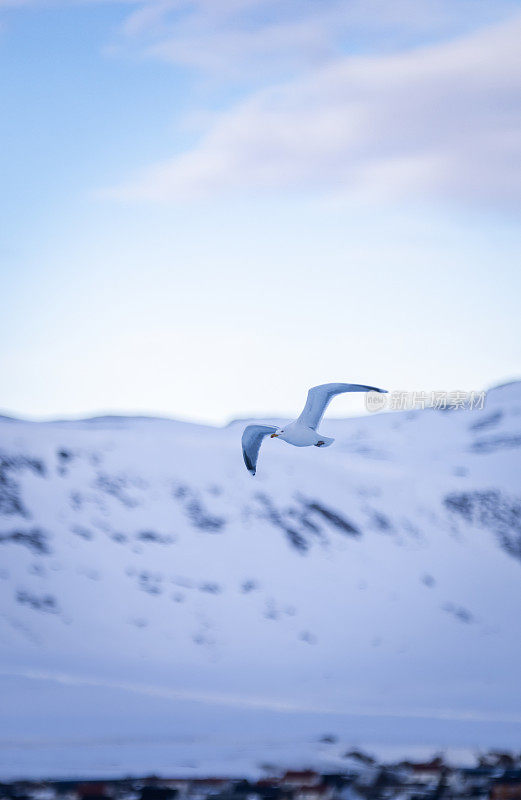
(0, 0), (521, 423)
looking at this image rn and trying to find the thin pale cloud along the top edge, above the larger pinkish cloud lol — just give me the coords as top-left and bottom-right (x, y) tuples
(118, 0), (514, 78)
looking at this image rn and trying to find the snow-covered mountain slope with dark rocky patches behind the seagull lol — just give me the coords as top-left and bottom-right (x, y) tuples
(0, 383), (521, 774)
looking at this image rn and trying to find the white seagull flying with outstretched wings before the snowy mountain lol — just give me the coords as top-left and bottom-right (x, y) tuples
(242, 383), (387, 475)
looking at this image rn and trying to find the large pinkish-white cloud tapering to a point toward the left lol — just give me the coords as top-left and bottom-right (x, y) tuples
(104, 16), (521, 206)
